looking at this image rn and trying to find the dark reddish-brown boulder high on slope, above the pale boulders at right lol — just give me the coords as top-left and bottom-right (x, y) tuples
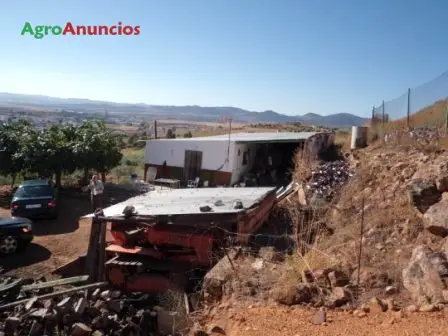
(408, 179), (442, 213)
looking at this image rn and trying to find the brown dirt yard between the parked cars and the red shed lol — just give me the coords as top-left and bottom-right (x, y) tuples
(0, 184), (141, 278)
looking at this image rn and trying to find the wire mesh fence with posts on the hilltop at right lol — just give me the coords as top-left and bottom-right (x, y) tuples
(371, 71), (448, 130)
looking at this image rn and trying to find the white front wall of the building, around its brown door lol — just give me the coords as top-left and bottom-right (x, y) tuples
(145, 140), (233, 172)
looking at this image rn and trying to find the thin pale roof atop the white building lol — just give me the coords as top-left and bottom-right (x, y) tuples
(149, 132), (319, 142)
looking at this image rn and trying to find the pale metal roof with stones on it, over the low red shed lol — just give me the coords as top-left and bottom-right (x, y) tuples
(82, 187), (275, 217)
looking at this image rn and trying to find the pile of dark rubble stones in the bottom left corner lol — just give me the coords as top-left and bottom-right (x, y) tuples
(0, 279), (186, 336)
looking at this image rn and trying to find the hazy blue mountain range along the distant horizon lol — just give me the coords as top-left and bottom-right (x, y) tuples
(0, 92), (368, 127)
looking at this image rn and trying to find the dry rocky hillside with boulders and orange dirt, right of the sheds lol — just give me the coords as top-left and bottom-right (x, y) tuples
(193, 145), (448, 335)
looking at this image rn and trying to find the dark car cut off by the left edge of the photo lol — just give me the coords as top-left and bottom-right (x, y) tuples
(0, 217), (33, 255)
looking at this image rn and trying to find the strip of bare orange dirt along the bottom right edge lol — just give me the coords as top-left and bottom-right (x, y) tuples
(200, 306), (448, 336)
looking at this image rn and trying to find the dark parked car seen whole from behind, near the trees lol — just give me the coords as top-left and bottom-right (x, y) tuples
(11, 180), (58, 219)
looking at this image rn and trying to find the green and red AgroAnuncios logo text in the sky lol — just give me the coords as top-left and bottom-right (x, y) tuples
(21, 22), (140, 39)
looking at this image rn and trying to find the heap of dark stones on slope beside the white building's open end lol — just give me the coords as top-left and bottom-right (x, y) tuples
(306, 160), (352, 201)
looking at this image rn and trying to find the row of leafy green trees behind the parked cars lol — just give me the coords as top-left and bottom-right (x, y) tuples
(0, 120), (123, 186)
